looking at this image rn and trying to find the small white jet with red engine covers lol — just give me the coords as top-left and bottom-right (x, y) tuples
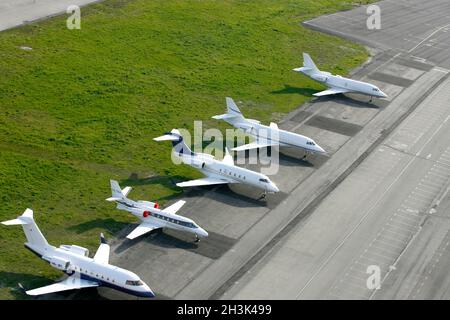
(106, 180), (208, 242)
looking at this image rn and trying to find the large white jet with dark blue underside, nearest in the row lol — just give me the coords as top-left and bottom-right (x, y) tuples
(2, 209), (155, 297)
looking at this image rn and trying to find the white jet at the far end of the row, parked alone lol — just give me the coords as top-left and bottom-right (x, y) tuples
(293, 53), (387, 102)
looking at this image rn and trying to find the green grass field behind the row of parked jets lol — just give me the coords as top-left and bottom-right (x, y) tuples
(0, 0), (368, 299)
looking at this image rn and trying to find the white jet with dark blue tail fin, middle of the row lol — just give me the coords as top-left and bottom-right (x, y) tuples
(154, 129), (280, 198)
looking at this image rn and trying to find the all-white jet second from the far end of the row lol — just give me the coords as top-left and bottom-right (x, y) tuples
(213, 97), (325, 157)
